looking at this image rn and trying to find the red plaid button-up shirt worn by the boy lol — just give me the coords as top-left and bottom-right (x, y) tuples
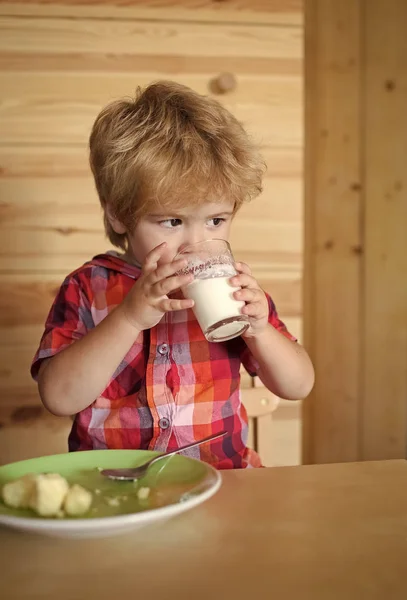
(31, 253), (294, 469)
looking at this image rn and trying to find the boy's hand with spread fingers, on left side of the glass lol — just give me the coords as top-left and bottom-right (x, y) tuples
(122, 242), (194, 331)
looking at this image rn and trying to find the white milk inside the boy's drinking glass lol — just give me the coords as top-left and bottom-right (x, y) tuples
(183, 275), (246, 341)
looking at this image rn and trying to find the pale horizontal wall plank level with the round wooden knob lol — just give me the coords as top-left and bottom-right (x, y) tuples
(0, 73), (302, 147)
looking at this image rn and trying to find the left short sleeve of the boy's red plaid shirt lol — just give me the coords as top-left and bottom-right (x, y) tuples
(31, 275), (94, 380)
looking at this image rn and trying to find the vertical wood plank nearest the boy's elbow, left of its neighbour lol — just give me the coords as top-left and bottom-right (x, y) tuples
(303, 0), (362, 463)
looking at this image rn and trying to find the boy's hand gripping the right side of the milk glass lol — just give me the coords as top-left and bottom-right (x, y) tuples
(230, 262), (269, 338)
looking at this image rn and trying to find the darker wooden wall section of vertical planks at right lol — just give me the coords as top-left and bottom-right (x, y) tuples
(303, 0), (407, 463)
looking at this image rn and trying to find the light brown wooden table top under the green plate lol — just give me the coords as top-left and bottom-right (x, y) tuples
(0, 461), (407, 600)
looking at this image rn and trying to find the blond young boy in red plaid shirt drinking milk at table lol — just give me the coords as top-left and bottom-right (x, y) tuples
(31, 81), (314, 469)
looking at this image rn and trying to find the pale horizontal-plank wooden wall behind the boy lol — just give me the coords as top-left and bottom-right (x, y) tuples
(0, 0), (303, 462)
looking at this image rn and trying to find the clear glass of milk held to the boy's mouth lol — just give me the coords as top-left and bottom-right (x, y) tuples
(176, 239), (249, 342)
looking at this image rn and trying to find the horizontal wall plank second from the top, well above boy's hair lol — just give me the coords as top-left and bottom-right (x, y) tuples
(0, 17), (302, 59)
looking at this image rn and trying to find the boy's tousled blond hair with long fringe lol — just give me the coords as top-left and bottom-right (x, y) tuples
(89, 81), (264, 249)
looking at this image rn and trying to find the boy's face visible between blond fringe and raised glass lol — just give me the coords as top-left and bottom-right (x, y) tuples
(121, 200), (234, 265)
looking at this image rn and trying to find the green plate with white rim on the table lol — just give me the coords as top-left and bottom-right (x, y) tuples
(0, 450), (221, 537)
